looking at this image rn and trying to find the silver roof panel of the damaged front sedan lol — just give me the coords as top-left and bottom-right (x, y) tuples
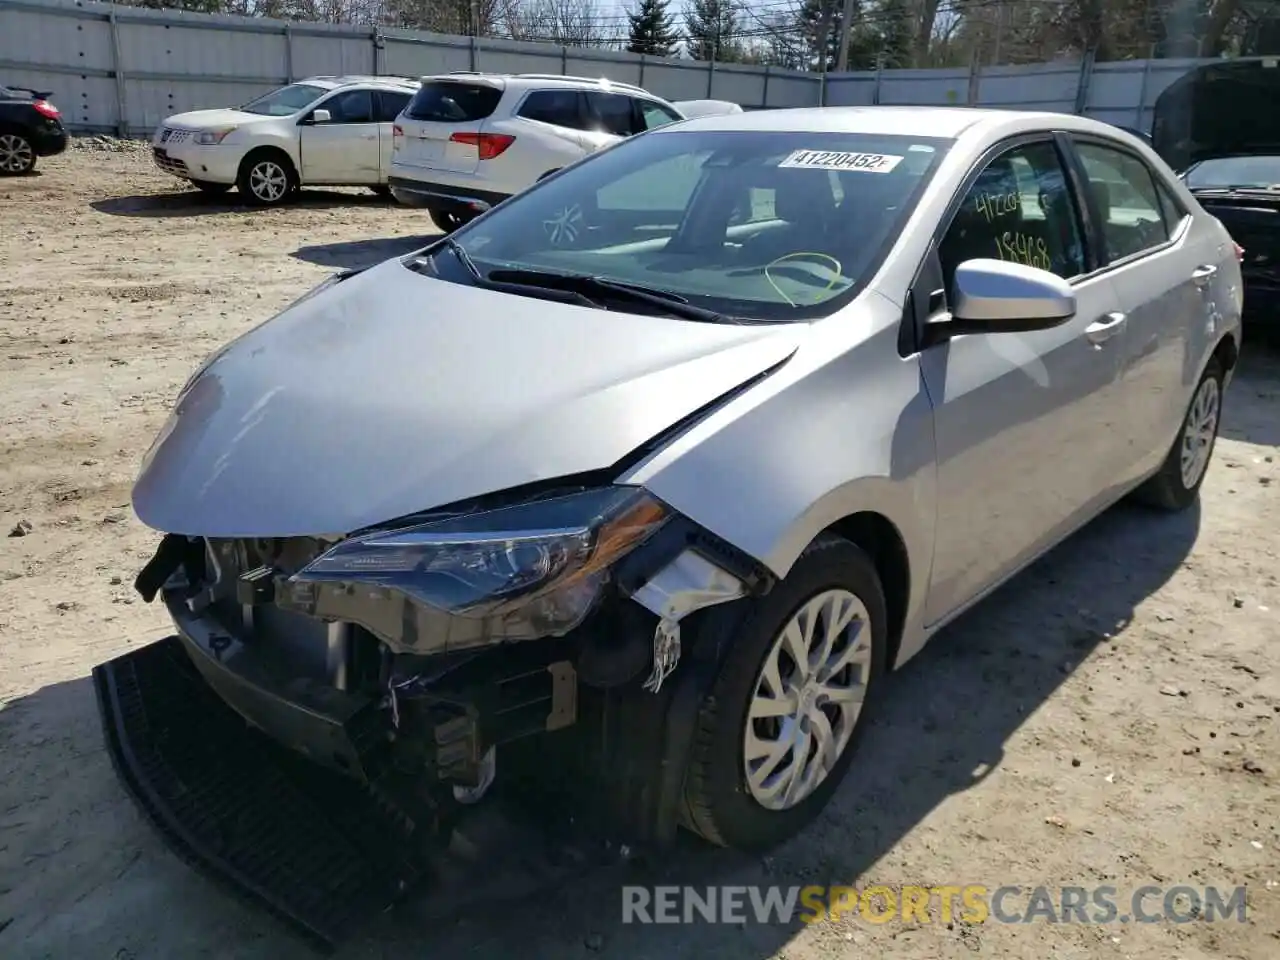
(654, 106), (1131, 140)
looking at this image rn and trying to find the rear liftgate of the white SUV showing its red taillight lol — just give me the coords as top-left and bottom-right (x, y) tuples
(394, 77), (506, 179)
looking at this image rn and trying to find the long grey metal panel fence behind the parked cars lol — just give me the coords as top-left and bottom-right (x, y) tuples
(0, 0), (1206, 136)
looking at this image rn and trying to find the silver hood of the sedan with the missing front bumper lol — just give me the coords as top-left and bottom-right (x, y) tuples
(133, 260), (806, 536)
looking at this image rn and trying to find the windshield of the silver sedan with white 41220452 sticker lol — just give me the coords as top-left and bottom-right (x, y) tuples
(433, 128), (951, 321)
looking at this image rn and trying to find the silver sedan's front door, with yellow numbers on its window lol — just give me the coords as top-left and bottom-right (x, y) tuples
(914, 134), (1124, 623)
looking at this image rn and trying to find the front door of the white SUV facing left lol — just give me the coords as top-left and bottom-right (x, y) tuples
(300, 90), (380, 184)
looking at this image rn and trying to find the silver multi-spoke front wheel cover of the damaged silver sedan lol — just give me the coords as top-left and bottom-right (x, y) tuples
(742, 590), (872, 810)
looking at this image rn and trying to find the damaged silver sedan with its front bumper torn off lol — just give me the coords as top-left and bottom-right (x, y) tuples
(95, 103), (1242, 941)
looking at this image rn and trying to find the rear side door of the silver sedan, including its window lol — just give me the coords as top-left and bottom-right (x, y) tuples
(1073, 136), (1213, 480)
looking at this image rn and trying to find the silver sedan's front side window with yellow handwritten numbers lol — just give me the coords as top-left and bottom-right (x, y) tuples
(940, 140), (1085, 289)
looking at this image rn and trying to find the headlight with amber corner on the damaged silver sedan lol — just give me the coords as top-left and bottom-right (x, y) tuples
(291, 486), (669, 640)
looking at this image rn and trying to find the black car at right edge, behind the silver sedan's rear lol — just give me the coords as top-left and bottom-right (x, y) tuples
(1181, 152), (1280, 325)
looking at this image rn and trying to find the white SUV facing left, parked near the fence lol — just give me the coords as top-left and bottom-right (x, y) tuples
(151, 77), (417, 206)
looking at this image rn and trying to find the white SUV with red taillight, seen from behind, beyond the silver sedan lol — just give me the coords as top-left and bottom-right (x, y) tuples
(389, 73), (685, 230)
